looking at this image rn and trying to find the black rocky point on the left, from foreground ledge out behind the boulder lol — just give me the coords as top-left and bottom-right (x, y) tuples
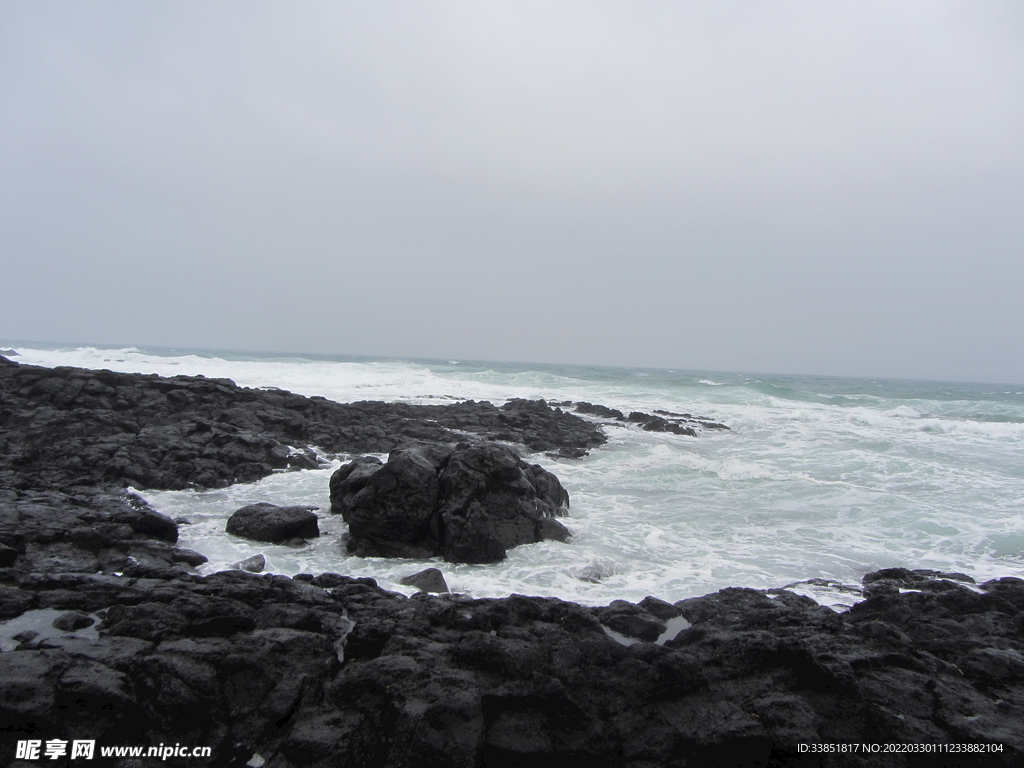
(0, 356), (605, 578)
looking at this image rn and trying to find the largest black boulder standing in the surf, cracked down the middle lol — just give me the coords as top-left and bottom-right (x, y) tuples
(331, 443), (569, 563)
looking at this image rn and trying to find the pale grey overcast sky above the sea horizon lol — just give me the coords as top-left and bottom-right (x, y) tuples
(0, 0), (1024, 383)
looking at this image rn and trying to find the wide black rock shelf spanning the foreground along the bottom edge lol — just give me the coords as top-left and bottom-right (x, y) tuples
(0, 570), (1024, 768)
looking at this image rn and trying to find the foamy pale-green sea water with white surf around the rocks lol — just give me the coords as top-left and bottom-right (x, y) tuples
(5, 343), (1024, 609)
